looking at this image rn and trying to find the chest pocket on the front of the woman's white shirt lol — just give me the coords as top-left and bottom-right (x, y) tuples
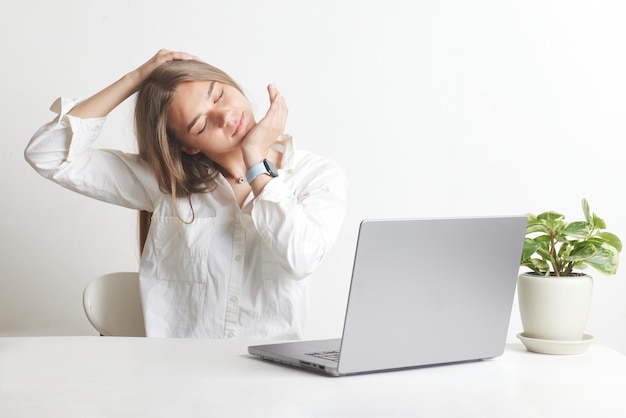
(149, 217), (215, 283)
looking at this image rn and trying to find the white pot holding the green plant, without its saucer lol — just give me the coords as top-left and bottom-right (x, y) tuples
(517, 273), (593, 341)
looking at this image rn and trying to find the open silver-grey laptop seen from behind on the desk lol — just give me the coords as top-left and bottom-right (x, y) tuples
(248, 216), (527, 376)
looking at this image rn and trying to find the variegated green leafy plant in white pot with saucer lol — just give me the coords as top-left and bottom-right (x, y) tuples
(517, 199), (622, 354)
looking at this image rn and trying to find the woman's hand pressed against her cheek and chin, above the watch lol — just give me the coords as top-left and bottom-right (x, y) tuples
(241, 84), (288, 167)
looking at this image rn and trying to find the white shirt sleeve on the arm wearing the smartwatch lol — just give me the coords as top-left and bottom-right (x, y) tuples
(252, 148), (347, 278)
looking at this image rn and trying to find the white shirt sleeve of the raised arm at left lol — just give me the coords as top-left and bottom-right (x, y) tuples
(24, 98), (158, 210)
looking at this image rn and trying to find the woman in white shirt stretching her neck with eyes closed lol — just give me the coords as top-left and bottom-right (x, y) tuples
(25, 50), (346, 339)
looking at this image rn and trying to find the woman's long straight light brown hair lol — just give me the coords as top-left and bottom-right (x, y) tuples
(135, 60), (243, 251)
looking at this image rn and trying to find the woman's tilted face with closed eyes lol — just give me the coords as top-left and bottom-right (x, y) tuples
(168, 81), (256, 160)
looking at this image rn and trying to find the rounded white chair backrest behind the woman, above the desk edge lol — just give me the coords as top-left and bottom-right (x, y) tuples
(83, 272), (146, 337)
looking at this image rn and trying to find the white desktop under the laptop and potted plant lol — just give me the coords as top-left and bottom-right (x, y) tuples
(0, 337), (626, 418)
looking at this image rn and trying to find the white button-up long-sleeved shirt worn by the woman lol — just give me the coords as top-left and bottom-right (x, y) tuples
(25, 99), (346, 339)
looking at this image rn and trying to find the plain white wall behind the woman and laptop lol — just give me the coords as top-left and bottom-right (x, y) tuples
(0, 0), (626, 354)
